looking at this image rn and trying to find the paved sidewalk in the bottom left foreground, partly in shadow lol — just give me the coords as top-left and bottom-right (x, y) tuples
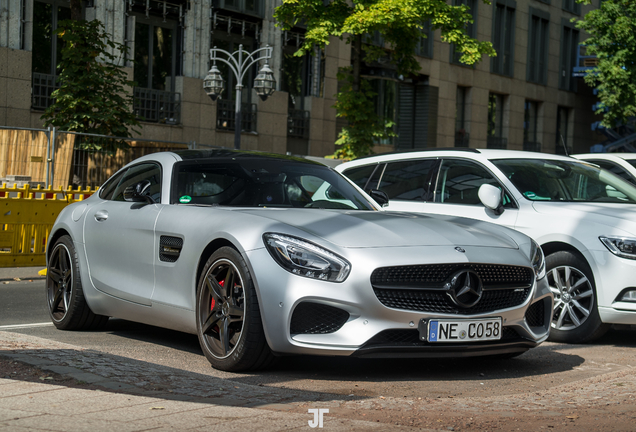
(0, 332), (422, 432)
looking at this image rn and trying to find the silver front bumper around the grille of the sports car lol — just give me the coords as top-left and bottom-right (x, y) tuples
(246, 246), (553, 357)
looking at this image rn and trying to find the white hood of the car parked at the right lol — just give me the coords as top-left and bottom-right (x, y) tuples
(532, 202), (636, 235)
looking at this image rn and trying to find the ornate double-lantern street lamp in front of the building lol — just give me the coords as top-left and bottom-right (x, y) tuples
(203, 45), (276, 150)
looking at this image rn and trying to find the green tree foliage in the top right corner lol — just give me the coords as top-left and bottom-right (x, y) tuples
(576, 0), (636, 128)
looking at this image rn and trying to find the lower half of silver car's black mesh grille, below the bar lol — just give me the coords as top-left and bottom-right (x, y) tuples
(373, 288), (530, 315)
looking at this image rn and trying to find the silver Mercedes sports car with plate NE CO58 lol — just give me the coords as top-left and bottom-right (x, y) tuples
(47, 150), (553, 371)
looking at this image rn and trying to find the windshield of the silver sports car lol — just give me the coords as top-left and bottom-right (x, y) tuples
(171, 158), (375, 210)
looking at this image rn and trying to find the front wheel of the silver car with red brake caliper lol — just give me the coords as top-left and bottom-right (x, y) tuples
(196, 247), (274, 372)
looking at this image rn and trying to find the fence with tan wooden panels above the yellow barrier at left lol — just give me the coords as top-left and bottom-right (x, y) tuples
(0, 126), (205, 188)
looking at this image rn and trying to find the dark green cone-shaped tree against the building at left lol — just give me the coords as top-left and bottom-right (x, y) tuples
(41, 20), (139, 151)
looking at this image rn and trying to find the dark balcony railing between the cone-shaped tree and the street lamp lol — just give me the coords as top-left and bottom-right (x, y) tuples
(133, 87), (181, 124)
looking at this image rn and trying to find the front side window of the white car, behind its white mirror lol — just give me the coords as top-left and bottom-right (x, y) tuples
(435, 159), (515, 208)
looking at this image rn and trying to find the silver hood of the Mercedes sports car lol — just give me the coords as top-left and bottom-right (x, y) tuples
(232, 208), (518, 249)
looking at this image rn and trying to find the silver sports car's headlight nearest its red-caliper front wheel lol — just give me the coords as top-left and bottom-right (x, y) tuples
(263, 233), (351, 282)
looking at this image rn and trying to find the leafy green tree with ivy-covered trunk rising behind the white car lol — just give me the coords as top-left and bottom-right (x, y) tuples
(274, 0), (496, 158)
